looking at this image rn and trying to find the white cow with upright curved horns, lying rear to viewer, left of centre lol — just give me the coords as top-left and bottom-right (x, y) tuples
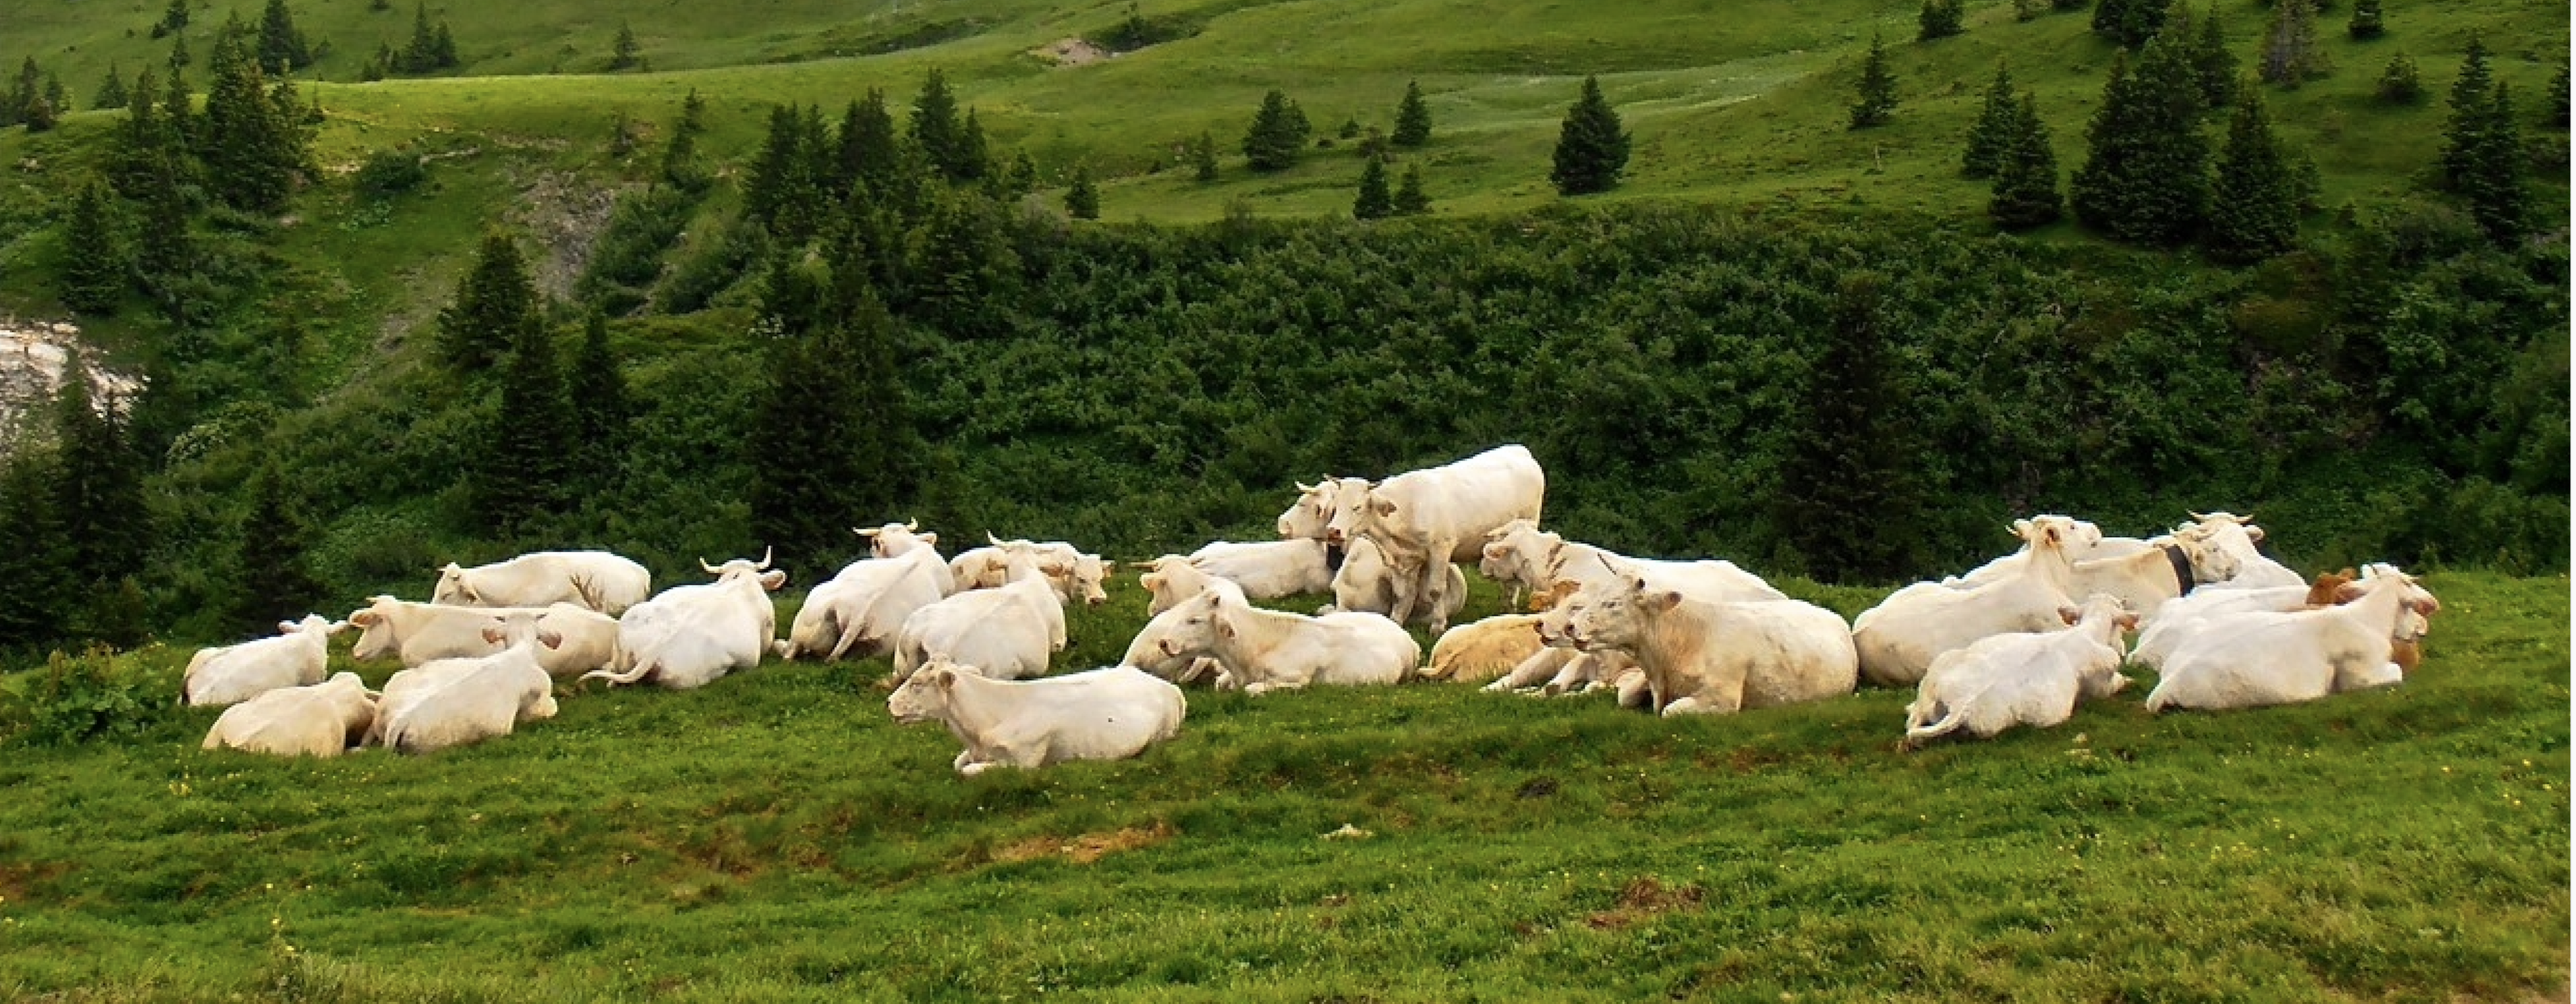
(583, 551), (788, 690)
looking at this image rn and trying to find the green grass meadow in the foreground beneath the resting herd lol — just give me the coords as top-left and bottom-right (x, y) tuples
(0, 571), (2568, 1001)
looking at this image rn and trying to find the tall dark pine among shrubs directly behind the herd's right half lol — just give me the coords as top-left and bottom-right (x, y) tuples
(1775, 273), (1919, 582)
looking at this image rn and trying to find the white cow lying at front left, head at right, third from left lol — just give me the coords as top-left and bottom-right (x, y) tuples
(374, 615), (564, 755)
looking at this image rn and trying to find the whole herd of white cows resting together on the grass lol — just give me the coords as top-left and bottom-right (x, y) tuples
(196, 446), (2439, 775)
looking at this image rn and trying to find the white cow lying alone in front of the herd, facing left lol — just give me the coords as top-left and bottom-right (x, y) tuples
(886, 659), (1190, 777)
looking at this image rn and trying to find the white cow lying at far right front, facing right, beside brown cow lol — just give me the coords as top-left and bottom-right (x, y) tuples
(2146, 567), (2442, 710)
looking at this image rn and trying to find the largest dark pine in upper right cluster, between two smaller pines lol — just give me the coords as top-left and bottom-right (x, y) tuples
(2071, 38), (2215, 245)
